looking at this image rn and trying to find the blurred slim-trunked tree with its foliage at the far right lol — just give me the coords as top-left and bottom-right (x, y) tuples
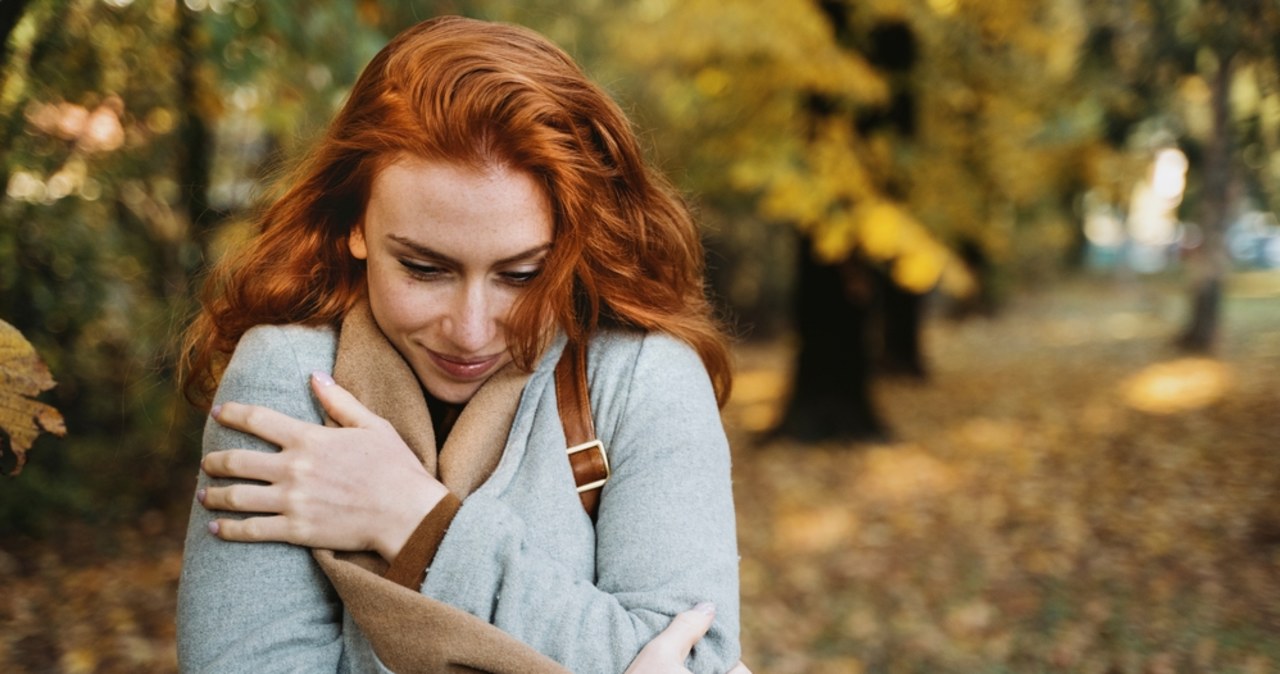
(1087, 0), (1280, 350)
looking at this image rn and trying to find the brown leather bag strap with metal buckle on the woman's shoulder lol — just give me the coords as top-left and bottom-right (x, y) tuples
(556, 340), (609, 522)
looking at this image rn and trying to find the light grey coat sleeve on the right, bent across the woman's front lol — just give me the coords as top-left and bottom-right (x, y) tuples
(422, 335), (740, 673)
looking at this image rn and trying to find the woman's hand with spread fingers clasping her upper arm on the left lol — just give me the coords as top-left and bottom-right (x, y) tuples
(196, 372), (447, 561)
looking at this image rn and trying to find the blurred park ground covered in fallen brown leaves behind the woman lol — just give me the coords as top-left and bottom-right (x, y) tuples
(0, 275), (1280, 674)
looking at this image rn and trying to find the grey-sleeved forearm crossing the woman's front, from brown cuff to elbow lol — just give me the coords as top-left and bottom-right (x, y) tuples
(422, 483), (739, 671)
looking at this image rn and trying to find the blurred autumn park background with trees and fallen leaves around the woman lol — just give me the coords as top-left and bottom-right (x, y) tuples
(0, 0), (1280, 674)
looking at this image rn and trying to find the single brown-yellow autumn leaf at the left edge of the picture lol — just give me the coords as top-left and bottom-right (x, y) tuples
(0, 321), (67, 474)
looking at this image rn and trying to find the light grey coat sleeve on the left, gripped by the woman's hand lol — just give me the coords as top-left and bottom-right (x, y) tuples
(178, 326), (353, 673)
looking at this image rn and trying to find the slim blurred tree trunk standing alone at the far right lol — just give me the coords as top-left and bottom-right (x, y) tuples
(1178, 55), (1233, 353)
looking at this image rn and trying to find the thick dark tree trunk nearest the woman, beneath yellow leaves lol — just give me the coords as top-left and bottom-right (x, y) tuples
(777, 238), (884, 443)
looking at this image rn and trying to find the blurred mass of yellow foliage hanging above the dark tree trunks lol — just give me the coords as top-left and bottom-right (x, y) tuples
(611, 0), (1085, 293)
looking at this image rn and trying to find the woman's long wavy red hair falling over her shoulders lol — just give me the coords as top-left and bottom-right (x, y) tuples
(182, 17), (732, 405)
